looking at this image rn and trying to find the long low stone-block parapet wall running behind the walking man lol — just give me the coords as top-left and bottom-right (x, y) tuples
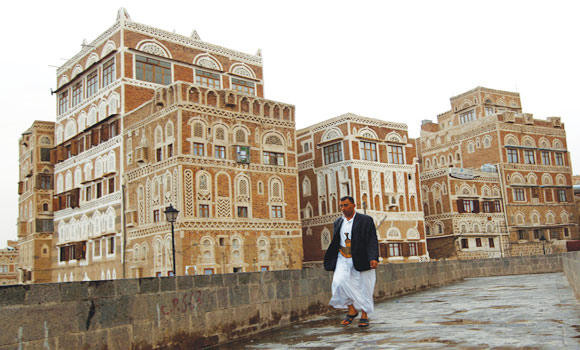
(0, 253), (571, 350)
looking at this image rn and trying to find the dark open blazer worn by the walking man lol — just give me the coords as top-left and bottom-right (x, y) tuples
(324, 212), (379, 271)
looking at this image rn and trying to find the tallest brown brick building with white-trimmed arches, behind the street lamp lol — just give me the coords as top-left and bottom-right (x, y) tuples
(44, 9), (302, 281)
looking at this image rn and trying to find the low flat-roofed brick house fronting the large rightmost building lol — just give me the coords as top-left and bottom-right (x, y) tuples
(421, 167), (509, 259)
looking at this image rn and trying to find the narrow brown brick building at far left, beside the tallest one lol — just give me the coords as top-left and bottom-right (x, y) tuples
(17, 120), (54, 283)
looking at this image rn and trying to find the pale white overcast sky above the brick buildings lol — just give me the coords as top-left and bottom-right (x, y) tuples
(0, 0), (580, 247)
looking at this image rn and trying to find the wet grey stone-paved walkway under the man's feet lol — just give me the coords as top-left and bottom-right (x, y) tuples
(221, 273), (580, 349)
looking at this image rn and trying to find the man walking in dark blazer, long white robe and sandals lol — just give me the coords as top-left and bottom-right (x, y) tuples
(324, 196), (379, 327)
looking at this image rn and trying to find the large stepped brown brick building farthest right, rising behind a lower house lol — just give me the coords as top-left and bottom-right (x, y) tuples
(419, 87), (578, 255)
